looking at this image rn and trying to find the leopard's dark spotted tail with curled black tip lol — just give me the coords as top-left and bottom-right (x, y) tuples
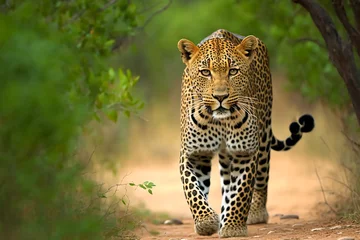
(271, 114), (315, 151)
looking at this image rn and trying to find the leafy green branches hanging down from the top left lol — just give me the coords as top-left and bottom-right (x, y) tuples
(4, 0), (141, 118)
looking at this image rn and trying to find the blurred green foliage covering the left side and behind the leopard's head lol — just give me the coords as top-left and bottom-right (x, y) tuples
(0, 0), (356, 239)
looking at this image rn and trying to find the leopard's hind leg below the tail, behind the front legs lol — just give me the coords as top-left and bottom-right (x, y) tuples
(247, 142), (270, 224)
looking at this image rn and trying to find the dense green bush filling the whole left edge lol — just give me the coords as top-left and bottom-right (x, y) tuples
(0, 0), (147, 240)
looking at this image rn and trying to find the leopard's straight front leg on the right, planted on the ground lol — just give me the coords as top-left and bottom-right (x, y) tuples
(219, 153), (257, 237)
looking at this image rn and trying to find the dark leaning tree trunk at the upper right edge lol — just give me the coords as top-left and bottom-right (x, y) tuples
(293, 0), (360, 126)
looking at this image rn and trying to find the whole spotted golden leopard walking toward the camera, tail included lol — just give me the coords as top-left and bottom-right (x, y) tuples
(177, 29), (315, 238)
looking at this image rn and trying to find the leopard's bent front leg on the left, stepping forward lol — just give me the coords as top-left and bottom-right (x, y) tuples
(180, 153), (219, 235)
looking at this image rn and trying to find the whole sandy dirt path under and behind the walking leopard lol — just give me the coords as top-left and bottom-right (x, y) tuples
(117, 153), (360, 240)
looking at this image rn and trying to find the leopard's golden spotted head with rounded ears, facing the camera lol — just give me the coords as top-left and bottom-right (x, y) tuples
(178, 35), (258, 120)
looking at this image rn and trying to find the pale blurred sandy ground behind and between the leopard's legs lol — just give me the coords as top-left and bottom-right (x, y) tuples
(124, 153), (333, 219)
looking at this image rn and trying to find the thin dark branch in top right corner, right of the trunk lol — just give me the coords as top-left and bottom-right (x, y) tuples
(333, 0), (360, 57)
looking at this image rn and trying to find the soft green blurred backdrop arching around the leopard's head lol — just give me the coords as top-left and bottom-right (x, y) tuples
(120, 0), (349, 107)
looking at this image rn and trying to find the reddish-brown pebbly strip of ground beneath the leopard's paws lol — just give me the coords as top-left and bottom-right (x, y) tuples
(140, 218), (360, 240)
